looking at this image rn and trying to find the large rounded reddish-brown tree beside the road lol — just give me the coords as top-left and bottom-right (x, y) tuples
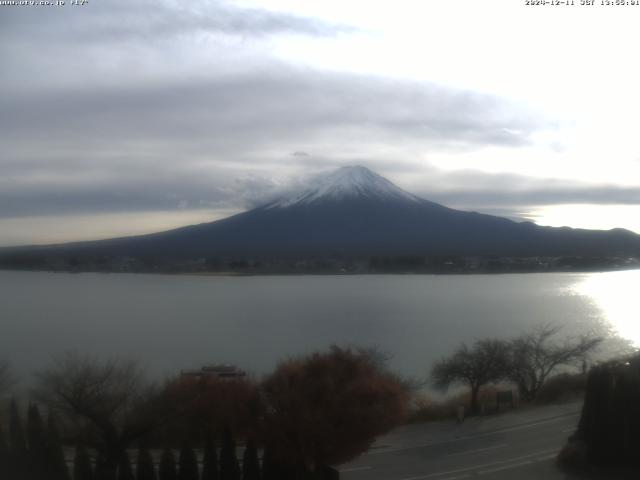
(262, 346), (410, 471)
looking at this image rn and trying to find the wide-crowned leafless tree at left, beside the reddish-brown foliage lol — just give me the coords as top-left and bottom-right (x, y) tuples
(34, 352), (181, 479)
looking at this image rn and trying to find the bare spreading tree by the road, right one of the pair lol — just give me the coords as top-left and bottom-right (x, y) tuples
(507, 324), (602, 401)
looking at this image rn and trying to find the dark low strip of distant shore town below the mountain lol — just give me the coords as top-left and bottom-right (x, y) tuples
(0, 253), (640, 275)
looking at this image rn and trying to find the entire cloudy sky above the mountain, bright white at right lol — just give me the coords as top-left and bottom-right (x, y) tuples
(0, 0), (640, 245)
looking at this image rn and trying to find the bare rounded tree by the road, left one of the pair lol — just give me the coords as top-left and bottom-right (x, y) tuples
(431, 339), (509, 413)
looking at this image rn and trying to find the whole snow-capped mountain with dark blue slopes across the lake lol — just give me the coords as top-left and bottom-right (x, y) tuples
(0, 166), (640, 268)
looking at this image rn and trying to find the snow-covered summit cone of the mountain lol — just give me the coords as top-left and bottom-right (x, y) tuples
(269, 165), (420, 208)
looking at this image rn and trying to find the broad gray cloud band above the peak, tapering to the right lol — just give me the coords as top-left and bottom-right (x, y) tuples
(0, 65), (548, 147)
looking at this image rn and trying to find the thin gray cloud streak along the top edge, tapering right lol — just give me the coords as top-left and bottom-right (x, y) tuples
(0, 0), (355, 43)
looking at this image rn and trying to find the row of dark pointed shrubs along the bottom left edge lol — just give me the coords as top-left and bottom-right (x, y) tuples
(0, 403), (339, 480)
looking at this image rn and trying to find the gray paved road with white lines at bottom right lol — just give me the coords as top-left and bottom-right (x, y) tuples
(340, 403), (581, 480)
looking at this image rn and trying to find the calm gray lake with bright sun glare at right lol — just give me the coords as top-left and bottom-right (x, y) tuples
(0, 271), (640, 378)
